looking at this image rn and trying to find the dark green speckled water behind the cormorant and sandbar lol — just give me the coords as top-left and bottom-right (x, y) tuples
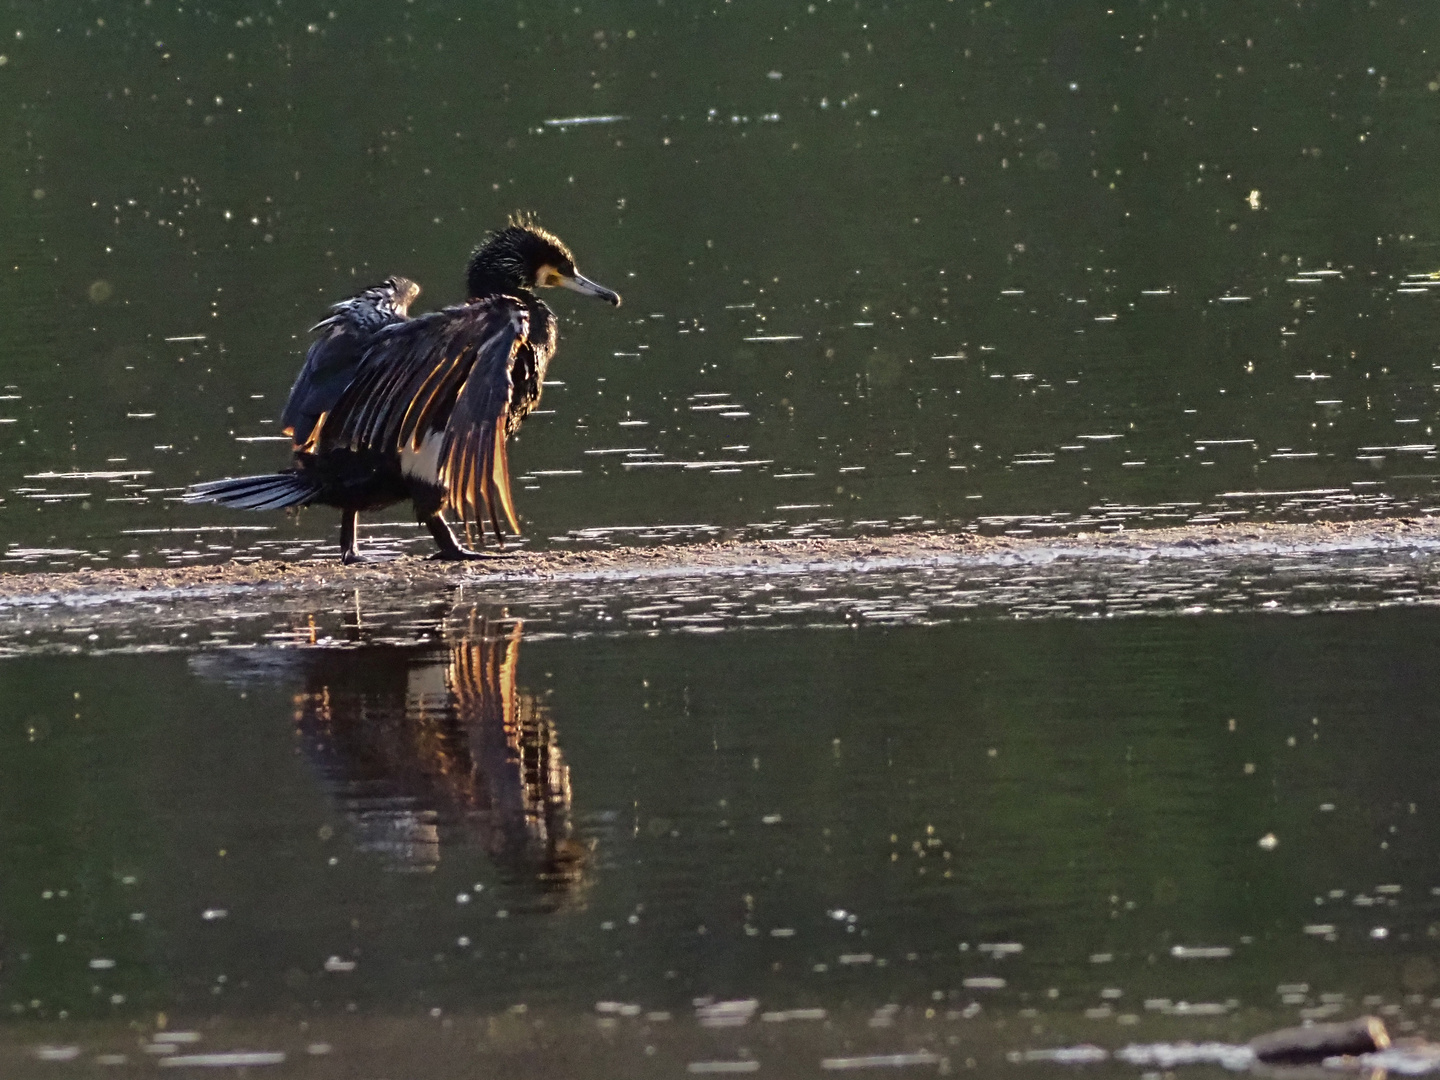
(0, 0), (1440, 567)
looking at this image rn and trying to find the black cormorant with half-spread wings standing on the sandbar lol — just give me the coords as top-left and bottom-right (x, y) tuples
(184, 219), (621, 563)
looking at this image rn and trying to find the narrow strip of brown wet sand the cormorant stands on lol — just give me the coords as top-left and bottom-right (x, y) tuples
(0, 518), (1440, 606)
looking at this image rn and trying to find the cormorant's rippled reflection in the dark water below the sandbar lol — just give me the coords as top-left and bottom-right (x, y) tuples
(192, 621), (589, 894)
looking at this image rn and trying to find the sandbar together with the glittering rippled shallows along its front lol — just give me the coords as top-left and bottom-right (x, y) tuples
(0, 518), (1440, 655)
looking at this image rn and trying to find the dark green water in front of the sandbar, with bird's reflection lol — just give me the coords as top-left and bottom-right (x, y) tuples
(0, 608), (1440, 1074)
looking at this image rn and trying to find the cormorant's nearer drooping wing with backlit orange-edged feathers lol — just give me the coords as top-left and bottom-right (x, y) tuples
(323, 297), (530, 531)
